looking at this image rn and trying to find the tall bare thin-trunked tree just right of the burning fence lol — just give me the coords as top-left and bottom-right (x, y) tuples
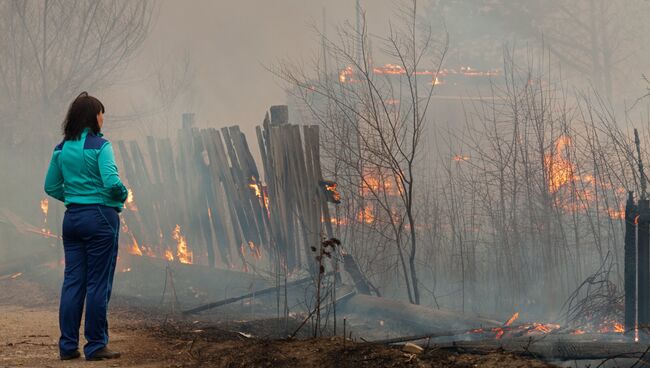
(276, 1), (447, 304)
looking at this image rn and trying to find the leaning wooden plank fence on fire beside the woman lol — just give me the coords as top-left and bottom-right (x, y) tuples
(110, 106), (335, 269)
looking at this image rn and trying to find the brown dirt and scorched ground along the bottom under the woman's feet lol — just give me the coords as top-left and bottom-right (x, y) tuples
(0, 277), (551, 368)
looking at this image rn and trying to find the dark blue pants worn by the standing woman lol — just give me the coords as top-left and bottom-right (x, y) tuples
(59, 204), (120, 357)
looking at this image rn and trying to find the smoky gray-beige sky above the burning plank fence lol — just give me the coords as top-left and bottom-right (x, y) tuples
(104, 0), (395, 141)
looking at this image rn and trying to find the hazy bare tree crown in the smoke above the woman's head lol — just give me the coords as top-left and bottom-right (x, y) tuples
(0, 0), (154, 135)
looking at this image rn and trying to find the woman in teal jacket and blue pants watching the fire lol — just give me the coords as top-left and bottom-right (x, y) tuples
(45, 92), (128, 360)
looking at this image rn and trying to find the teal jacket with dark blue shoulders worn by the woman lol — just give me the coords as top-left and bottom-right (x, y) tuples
(45, 128), (128, 211)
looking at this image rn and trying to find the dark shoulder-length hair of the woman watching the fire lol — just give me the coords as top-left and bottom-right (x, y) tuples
(62, 91), (104, 141)
